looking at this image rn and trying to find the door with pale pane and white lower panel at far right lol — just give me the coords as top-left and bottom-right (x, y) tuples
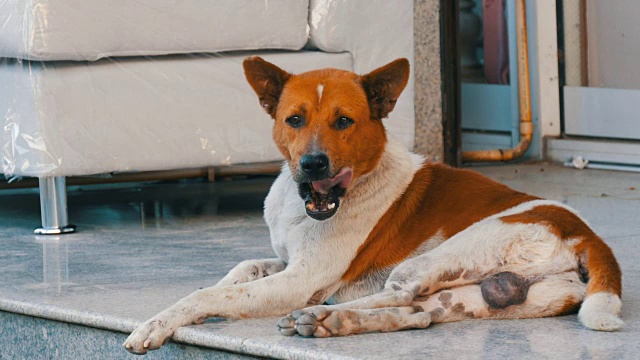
(559, 0), (640, 142)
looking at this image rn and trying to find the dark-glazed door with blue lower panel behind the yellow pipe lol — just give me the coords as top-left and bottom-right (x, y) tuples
(459, 0), (520, 151)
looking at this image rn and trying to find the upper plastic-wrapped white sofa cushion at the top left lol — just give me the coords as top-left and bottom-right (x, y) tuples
(0, 0), (309, 60)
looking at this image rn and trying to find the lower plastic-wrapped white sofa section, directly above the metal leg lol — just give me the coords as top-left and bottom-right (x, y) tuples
(0, 51), (353, 177)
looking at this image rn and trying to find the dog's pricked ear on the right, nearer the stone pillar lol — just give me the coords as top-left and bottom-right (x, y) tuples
(361, 58), (409, 120)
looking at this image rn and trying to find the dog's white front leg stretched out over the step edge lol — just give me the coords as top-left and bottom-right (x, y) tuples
(124, 266), (329, 354)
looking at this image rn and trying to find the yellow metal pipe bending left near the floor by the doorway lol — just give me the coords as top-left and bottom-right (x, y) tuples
(462, 0), (533, 163)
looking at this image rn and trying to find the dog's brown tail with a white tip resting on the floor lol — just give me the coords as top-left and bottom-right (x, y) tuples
(575, 233), (624, 331)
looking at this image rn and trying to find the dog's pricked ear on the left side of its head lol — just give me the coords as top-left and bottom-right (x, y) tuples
(242, 56), (291, 119)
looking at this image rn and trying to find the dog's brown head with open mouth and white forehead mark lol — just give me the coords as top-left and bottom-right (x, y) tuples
(243, 57), (409, 220)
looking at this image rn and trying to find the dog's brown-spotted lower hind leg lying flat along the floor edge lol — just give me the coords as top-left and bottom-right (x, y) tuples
(278, 271), (586, 337)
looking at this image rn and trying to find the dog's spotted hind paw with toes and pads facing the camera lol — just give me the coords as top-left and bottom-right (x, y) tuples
(278, 306), (332, 337)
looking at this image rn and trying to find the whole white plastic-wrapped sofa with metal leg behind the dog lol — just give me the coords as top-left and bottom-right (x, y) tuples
(0, 0), (415, 233)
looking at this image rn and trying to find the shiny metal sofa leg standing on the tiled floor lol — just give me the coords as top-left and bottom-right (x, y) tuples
(34, 176), (76, 235)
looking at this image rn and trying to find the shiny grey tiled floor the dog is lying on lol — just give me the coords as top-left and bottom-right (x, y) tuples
(0, 164), (640, 359)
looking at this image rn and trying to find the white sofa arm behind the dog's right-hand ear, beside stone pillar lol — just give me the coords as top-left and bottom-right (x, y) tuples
(309, 0), (415, 149)
